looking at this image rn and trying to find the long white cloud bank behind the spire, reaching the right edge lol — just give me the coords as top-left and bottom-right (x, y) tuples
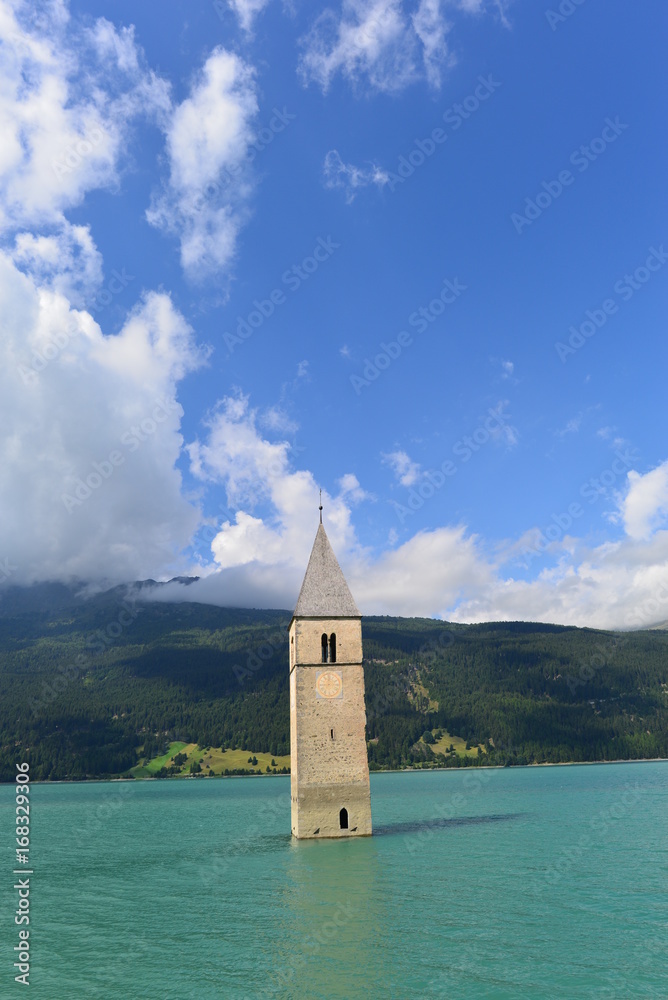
(151, 404), (668, 629)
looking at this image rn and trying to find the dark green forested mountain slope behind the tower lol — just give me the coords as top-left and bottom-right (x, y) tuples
(0, 584), (668, 781)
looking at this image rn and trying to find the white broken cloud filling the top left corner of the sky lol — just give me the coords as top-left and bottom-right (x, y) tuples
(0, 0), (169, 231)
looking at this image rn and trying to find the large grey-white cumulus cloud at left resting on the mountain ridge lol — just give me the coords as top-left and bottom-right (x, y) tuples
(0, 253), (203, 583)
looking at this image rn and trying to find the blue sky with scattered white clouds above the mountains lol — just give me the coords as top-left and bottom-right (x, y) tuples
(0, 0), (668, 627)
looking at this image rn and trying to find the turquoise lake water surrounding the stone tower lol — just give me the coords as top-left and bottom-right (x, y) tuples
(0, 762), (668, 1000)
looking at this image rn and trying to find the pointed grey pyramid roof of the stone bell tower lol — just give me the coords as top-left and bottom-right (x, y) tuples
(294, 524), (360, 618)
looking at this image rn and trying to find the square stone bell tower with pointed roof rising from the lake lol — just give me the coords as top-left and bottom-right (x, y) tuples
(290, 508), (371, 837)
